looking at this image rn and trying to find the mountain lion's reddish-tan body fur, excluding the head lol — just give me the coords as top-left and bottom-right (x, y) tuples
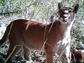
(0, 2), (79, 63)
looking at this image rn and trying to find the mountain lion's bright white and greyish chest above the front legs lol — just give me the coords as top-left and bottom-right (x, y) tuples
(53, 30), (71, 54)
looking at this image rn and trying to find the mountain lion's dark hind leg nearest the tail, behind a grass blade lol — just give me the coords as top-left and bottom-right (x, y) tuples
(6, 44), (22, 63)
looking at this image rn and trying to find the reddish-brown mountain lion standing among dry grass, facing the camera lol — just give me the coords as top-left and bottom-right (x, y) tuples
(0, 3), (79, 63)
